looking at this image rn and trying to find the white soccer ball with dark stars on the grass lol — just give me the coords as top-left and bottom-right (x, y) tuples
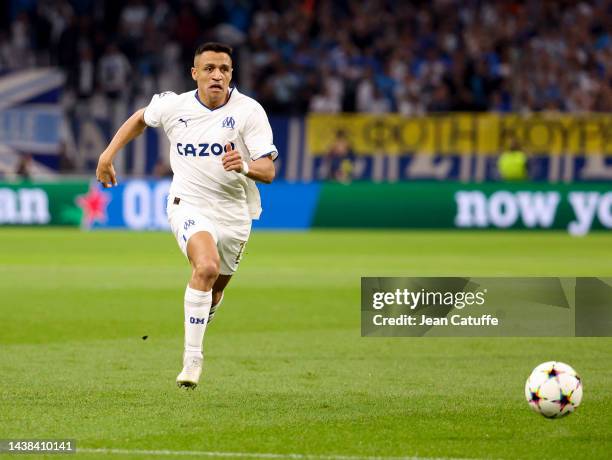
(525, 361), (582, 418)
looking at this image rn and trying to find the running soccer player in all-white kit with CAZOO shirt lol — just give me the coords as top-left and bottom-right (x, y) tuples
(96, 43), (278, 388)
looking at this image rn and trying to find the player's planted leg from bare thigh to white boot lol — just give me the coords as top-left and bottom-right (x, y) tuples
(176, 231), (219, 387)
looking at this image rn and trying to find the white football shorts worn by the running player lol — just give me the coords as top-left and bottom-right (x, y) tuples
(167, 202), (248, 275)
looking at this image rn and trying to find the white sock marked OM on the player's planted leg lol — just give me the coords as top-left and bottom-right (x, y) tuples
(185, 286), (212, 356)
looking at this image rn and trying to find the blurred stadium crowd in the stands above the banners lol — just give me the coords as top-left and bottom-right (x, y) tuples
(0, 0), (612, 115)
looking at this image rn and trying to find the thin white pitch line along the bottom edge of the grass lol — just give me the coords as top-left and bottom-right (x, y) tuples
(76, 447), (486, 460)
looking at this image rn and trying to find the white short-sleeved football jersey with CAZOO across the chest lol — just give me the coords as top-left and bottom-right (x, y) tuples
(144, 88), (278, 232)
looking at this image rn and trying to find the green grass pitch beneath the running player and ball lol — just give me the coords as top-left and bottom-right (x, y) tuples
(0, 229), (612, 459)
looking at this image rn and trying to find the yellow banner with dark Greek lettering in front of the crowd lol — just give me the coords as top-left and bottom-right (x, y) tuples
(306, 113), (612, 155)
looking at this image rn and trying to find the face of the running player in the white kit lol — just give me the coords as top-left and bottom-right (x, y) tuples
(191, 51), (232, 106)
